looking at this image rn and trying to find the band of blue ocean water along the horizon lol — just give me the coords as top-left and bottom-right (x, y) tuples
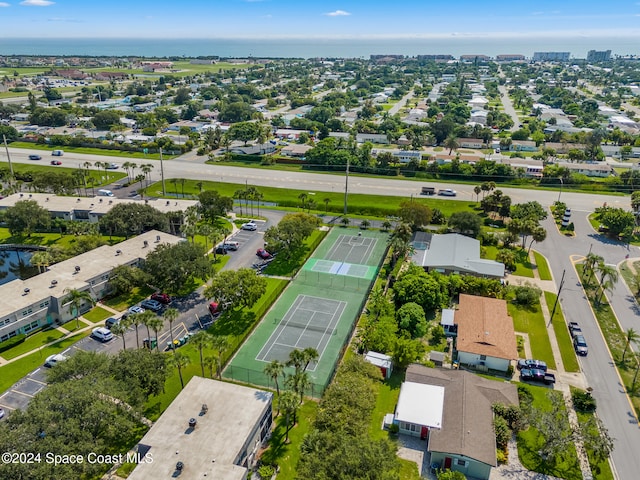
(0, 35), (640, 58)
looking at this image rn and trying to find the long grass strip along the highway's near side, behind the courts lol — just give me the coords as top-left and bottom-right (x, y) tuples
(146, 179), (477, 216)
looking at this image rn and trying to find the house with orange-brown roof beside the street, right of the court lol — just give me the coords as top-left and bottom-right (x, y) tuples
(455, 294), (518, 372)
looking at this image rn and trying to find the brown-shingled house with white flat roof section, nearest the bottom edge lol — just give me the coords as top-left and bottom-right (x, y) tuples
(398, 364), (519, 479)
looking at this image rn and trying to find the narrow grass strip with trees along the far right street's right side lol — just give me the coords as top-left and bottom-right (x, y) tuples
(576, 264), (640, 415)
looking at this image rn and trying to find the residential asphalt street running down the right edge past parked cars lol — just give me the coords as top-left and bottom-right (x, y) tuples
(535, 211), (640, 479)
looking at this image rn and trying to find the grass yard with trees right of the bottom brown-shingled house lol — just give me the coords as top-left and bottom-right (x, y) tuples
(517, 384), (582, 480)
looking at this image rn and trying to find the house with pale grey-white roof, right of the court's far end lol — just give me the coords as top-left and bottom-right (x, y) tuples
(411, 232), (504, 278)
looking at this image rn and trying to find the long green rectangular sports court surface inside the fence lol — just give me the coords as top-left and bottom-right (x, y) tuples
(223, 228), (388, 397)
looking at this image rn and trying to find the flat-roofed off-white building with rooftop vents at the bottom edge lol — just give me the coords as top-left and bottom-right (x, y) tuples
(129, 376), (273, 480)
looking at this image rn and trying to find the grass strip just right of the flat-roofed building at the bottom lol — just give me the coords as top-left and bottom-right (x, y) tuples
(261, 400), (318, 480)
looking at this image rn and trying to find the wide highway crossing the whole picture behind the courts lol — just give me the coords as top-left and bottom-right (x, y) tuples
(0, 148), (630, 212)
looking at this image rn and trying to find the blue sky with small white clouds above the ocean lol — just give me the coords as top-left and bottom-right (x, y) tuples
(0, 0), (640, 38)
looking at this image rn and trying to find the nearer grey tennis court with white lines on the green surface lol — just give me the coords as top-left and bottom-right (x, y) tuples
(256, 295), (347, 371)
